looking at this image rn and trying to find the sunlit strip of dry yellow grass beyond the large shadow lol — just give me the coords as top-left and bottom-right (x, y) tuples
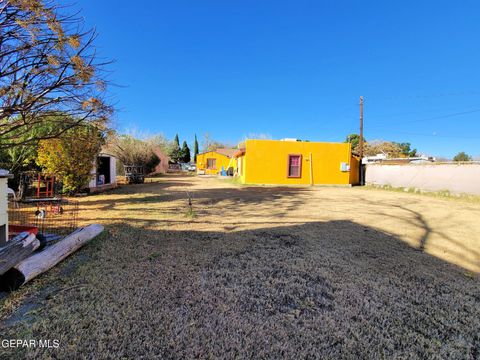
(81, 176), (480, 273)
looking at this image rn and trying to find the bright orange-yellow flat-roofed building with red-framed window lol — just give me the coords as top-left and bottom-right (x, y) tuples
(234, 139), (359, 185)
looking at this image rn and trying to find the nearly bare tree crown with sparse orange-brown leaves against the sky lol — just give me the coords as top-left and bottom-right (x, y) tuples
(0, 0), (112, 149)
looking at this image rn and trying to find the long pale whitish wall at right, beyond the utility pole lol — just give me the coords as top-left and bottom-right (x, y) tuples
(365, 163), (480, 195)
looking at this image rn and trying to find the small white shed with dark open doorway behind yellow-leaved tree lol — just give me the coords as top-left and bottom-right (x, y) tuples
(88, 153), (117, 192)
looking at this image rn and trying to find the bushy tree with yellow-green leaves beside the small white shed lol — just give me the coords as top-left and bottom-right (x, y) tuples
(37, 125), (104, 194)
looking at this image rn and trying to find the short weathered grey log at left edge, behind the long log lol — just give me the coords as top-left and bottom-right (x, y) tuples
(0, 232), (40, 275)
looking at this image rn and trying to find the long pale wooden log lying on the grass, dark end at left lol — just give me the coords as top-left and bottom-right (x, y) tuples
(0, 224), (103, 291)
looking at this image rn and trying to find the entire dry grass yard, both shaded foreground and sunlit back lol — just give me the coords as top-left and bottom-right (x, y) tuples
(0, 176), (480, 359)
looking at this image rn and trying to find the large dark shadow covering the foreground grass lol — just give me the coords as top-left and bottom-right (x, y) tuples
(2, 221), (480, 359)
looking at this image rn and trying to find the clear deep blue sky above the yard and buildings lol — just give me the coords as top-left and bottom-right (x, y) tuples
(75, 0), (480, 156)
